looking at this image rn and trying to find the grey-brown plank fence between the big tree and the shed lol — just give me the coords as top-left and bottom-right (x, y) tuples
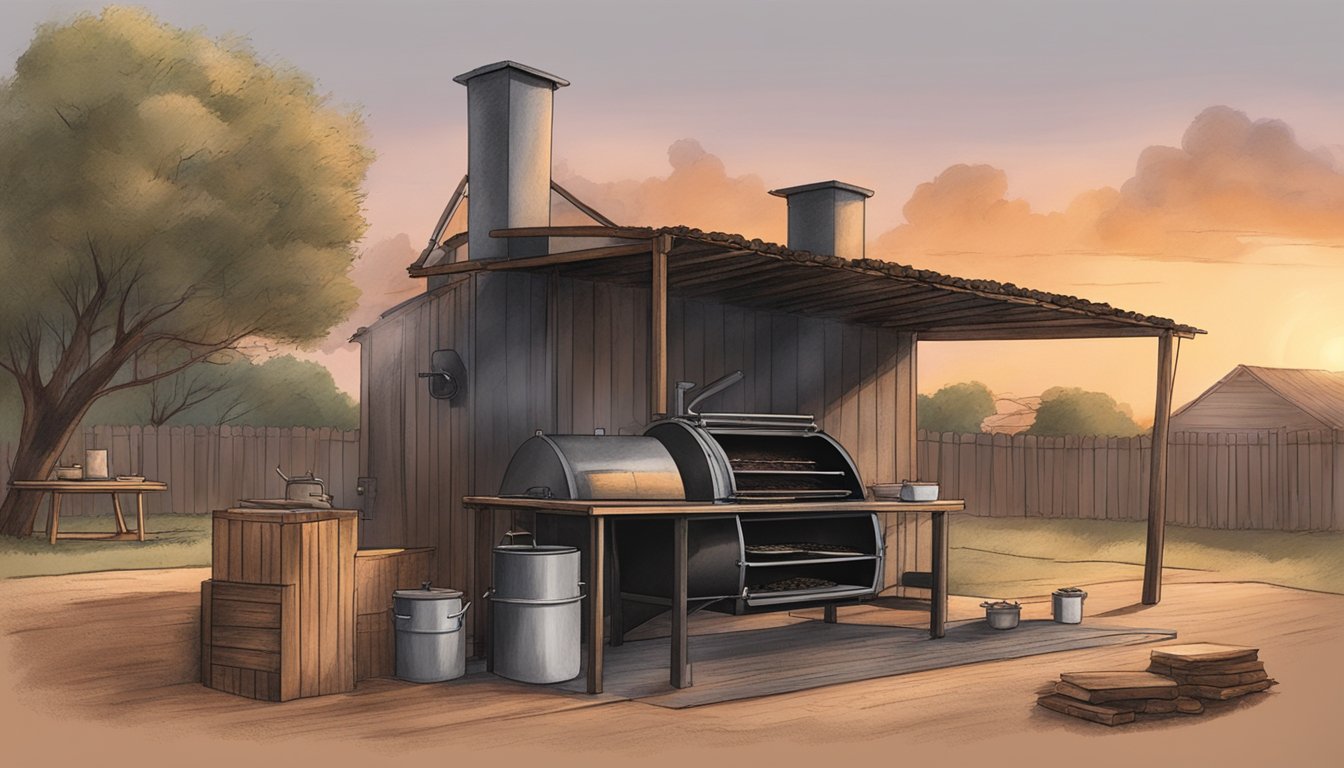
(0, 426), (359, 515)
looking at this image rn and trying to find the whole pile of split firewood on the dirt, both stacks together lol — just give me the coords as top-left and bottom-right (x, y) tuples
(1036, 643), (1275, 725)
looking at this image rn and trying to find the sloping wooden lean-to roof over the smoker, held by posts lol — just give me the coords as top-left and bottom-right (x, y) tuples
(409, 226), (1204, 342)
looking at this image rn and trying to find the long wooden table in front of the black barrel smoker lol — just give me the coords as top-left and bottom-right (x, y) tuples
(462, 496), (966, 694)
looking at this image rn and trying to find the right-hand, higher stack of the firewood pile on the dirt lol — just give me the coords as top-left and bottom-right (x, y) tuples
(1148, 643), (1277, 701)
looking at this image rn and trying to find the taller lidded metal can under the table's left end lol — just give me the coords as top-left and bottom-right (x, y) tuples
(485, 534), (583, 683)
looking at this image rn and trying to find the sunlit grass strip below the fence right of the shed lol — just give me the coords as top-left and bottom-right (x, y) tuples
(948, 518), (1344, 597)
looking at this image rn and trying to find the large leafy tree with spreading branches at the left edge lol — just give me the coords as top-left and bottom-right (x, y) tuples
(0, 8), (372, 535)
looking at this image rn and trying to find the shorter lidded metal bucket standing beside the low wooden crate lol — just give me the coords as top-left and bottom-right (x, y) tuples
(392, 581), (472, 683)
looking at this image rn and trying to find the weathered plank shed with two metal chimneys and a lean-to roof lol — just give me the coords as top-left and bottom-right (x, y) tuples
(355, 62), (1202, 642)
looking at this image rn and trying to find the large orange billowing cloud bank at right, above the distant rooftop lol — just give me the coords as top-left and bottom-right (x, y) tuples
(876, 106), (1344, 269)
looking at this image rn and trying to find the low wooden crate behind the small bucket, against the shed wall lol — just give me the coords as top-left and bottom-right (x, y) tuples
(355, 547), (434, 681)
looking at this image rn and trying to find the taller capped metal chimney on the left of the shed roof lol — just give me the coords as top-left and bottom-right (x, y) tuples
(453, 62), (570, 258)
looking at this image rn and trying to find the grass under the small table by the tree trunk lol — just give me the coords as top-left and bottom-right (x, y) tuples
(0, 515), (211, 578)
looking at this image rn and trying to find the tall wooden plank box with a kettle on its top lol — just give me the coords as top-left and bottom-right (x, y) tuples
(200, 510), (358, 701)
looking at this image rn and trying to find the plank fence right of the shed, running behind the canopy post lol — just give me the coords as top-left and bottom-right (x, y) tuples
(918, 430), (1344, 531)
